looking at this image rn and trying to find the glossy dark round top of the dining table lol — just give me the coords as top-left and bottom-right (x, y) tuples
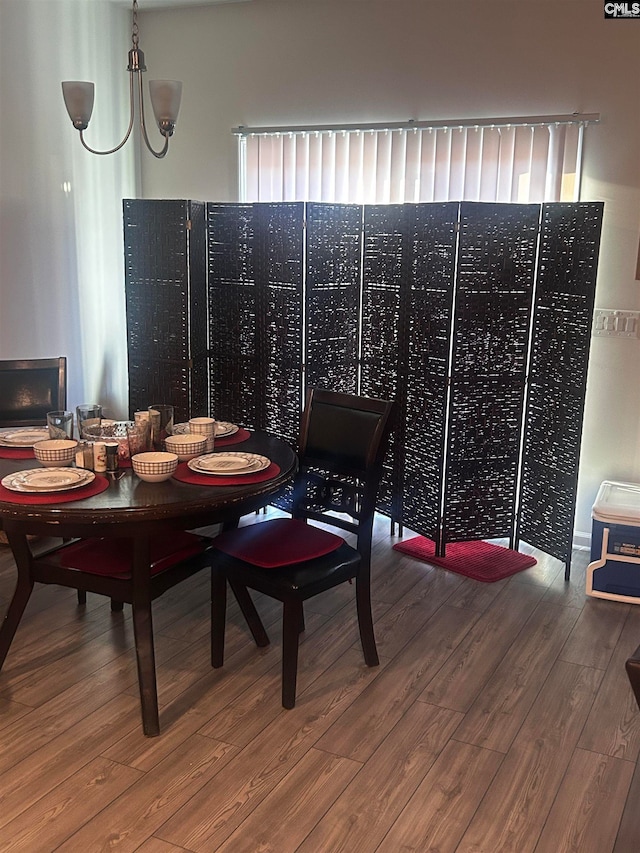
(0, 432), (298, 536)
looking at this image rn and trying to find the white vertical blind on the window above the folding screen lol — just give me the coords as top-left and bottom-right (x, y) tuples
(239, 117), (597, 204)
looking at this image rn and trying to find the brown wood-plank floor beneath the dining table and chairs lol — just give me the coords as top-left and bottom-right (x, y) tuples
(0, 521), (640, 853)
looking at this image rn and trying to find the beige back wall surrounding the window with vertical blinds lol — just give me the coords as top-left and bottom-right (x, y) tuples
(143, 0), (640, 535)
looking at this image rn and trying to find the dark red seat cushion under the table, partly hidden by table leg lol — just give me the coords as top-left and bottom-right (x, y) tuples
(60, 530), (204, 578)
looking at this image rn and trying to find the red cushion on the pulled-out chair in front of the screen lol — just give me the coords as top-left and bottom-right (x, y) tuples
(213, 518), (344, 569)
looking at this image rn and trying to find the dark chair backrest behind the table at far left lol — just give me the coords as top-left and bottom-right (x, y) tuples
(0, 356), (67, 427)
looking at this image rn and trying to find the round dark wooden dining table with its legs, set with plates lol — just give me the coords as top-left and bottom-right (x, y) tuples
(0, 429), (298, 733)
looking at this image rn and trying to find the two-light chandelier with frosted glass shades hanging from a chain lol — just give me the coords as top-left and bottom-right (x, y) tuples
(62, 0), (182, 158)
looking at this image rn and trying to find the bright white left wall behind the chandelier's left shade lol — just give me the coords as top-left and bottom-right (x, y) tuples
(0, 0), (136, 416)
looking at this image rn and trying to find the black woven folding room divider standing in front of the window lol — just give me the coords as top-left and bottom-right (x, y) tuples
(125, 201), (603, 568)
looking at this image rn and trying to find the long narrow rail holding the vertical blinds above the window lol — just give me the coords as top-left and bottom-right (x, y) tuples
(232, 113), (600, 136)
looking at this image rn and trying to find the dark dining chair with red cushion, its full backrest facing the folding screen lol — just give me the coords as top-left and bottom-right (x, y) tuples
(211, 389), (393, 708)
